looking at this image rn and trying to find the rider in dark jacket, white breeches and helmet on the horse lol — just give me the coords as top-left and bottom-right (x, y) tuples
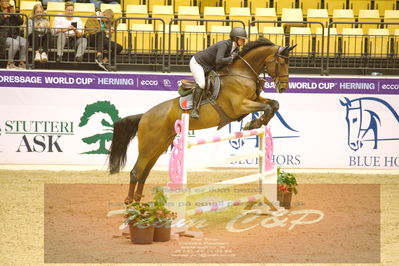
(190, 27), (247, 119)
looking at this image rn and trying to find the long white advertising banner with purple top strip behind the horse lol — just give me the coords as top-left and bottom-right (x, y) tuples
(0, 71), (399, 169)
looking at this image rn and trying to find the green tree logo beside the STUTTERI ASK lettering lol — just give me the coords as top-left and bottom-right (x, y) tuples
(79, 101), (121, 154)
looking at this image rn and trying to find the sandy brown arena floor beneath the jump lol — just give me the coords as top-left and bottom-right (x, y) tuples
(0, 169), (399, 265)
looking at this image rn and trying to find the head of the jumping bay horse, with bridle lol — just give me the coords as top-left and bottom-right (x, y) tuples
(265, 45), (296, 93)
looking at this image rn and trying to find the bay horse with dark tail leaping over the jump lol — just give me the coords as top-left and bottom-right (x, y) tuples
(108, 38), (295, 204)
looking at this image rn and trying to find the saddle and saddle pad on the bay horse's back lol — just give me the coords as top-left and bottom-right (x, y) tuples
(178, 70), (220, 110)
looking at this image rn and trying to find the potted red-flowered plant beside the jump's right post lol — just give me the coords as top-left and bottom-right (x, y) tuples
(277, 167), (298, 209)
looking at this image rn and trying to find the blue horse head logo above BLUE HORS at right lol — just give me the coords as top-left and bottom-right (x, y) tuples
(340, 97), (399, 151)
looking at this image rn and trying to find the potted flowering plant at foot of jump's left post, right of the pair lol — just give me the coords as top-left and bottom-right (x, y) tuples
(153, 187), (176, 242)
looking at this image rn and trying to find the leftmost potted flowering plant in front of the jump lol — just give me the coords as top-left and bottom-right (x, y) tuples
(124, 202), (156, 244)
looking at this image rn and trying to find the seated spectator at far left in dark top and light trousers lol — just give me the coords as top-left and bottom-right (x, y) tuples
(0, 0), (26, 69)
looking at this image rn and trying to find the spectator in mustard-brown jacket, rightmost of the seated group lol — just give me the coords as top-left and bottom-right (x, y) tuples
(85, 9), (122, 70)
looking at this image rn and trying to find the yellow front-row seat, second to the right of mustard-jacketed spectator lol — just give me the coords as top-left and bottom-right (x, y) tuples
(131, 24), (154, 53)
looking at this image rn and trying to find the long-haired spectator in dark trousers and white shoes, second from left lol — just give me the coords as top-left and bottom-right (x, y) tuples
(28, 3), (51, 62)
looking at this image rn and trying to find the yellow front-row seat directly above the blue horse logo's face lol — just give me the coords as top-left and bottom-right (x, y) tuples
(342, 28), (364, 57)
